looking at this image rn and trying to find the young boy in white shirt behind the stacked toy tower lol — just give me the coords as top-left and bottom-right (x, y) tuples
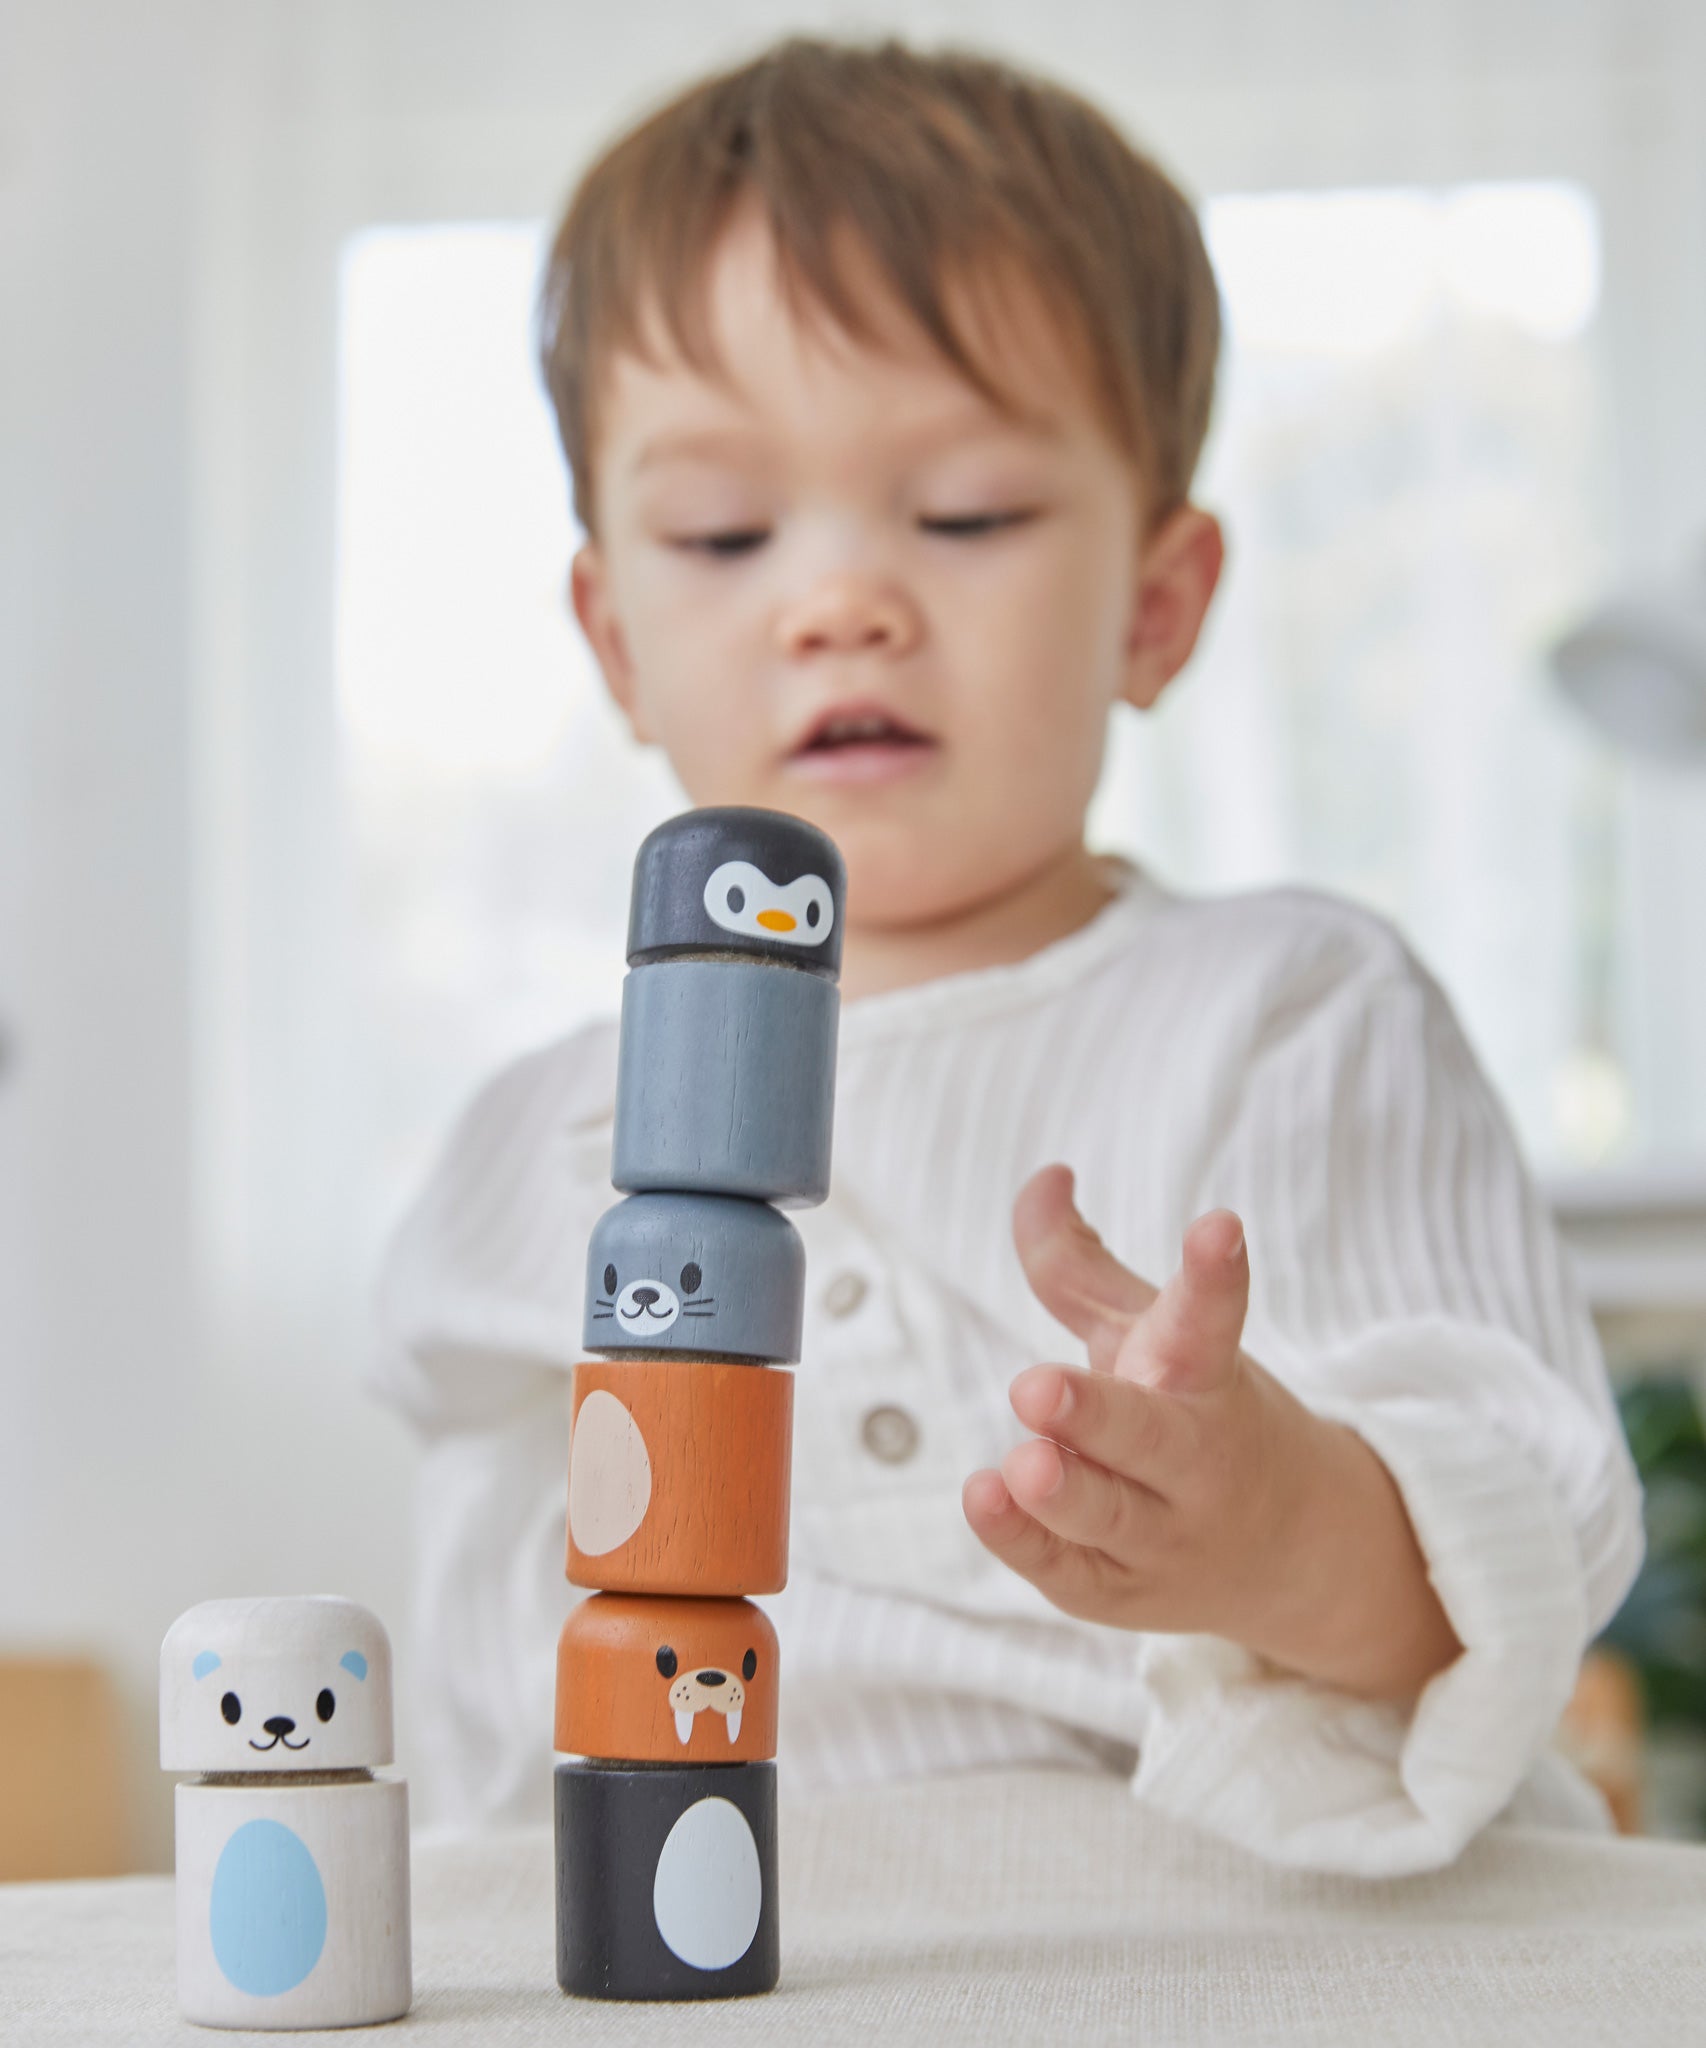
(368, 41), (1640, 1872)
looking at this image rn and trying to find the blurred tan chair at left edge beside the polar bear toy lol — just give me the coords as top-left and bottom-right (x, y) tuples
(0, 1657), (129, 1882)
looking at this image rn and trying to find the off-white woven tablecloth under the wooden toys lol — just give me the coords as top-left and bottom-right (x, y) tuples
(0, 1772), (1706, 2048)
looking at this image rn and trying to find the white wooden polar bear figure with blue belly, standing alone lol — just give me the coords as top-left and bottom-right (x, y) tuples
(160, 1595), (412, 2030)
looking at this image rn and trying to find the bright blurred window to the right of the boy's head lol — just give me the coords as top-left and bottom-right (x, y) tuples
(1098, 184), (1632, 1165)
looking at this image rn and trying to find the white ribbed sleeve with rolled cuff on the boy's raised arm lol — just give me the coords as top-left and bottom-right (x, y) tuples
(1135, 940), (1643, 1876)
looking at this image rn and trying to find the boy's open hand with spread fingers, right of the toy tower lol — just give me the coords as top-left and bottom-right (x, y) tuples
(965, 1165), (1458, 1696)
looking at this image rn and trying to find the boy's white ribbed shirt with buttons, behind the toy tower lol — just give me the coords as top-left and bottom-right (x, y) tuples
(375, 862), (1640, 1874)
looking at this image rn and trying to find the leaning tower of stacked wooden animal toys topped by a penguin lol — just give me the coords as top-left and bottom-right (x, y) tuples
(557, 809), (844, 1999)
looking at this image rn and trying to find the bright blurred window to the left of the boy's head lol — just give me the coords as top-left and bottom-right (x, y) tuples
(338, 223), (684, 1217)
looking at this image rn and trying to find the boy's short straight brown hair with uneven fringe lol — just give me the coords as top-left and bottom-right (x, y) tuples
(539, 37), (1221, 532)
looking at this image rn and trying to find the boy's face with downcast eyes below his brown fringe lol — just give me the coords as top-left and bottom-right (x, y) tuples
(573, 213), (1219, 926)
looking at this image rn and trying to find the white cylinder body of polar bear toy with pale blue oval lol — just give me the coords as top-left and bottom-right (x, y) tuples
(178, 1778), (412, 2030)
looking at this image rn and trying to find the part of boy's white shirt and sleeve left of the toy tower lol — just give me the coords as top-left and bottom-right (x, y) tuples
(369, 1026), (614, 1825)
